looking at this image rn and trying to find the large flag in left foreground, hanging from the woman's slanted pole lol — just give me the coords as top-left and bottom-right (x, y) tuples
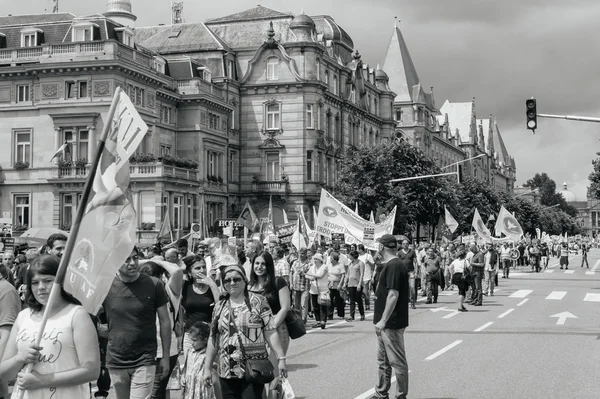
(63, 88), (148, 314)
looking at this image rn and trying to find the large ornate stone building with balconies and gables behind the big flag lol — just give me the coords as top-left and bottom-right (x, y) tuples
(0, 0), (396, 241)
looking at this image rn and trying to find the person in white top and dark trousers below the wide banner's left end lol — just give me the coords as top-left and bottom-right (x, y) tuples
(306, 253), (331, 329)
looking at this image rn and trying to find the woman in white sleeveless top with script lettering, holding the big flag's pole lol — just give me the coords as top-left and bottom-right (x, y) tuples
(0, 255), (100, 399)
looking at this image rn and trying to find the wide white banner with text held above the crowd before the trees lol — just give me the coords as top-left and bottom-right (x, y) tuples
(315, 189), (396, 250)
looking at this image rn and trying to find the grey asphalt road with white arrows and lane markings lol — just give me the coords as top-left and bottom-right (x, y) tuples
(105, 249), (600, 399)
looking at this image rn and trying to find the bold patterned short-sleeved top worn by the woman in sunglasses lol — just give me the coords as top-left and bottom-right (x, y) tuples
(212, 293), (275, 379)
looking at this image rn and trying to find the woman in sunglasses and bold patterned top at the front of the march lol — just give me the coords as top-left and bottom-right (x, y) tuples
(202, 264), (287, 399)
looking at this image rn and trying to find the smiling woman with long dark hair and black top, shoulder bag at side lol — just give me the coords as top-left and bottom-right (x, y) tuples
(248, 251), (291, 395)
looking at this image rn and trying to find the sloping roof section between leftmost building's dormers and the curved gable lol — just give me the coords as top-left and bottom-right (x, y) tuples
(135, 22), (230, 54)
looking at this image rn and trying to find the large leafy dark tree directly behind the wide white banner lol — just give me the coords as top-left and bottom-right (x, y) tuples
(334, 140), (456, 238)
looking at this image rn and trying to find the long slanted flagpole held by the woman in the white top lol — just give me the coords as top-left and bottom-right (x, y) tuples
(18, 87), (121, 399)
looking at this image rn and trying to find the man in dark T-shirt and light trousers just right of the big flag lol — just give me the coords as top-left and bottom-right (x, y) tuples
(103, 248), (172, 399)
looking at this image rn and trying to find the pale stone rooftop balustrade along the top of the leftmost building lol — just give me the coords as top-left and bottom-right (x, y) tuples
(0, 40), (154, 69)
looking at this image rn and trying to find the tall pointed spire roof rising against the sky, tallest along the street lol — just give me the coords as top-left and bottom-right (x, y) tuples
(383, 26), (420, 102)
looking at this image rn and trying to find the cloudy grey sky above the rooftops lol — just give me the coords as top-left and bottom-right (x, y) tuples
(8, 0), (600, 200)
